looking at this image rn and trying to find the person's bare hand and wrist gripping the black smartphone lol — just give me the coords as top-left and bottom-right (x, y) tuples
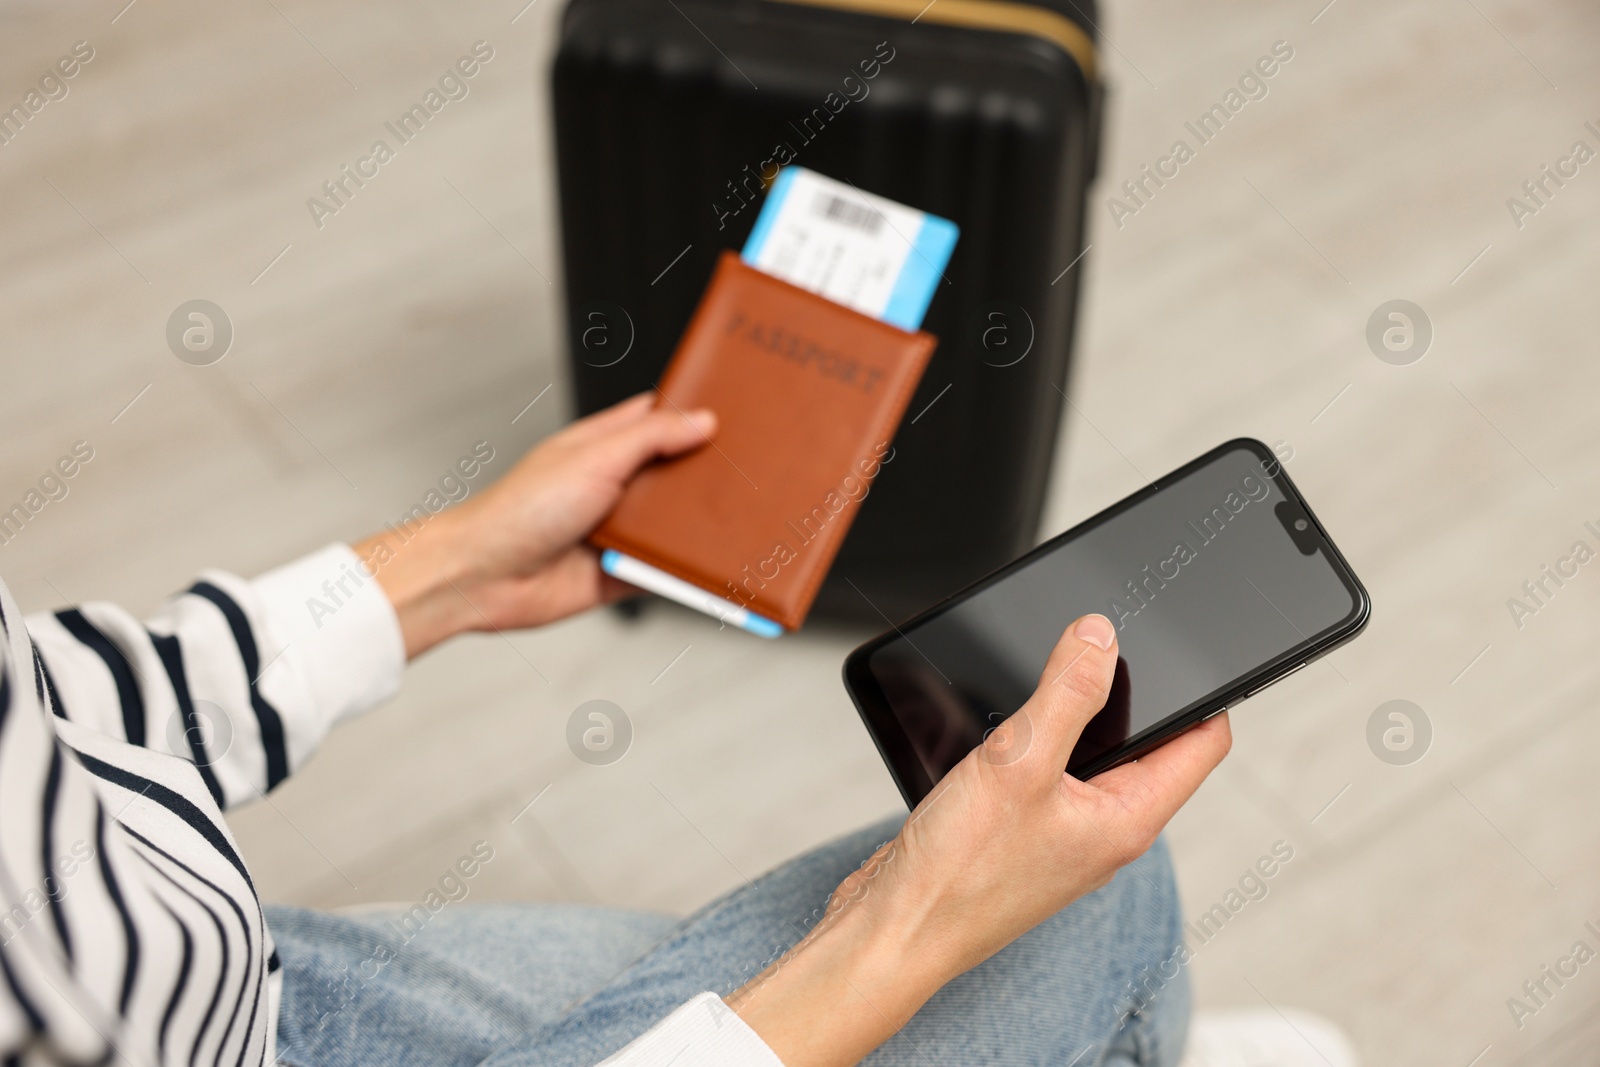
(728, 614), (1230, 1067)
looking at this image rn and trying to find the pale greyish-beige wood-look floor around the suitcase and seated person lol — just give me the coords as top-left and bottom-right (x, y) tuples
(0, 0), (1600, 1067)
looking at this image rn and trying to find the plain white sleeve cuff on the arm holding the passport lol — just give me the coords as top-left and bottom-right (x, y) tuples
(251, 544), (405, 729)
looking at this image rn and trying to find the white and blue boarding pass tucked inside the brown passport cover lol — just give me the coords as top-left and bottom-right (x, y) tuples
(600, 166), (960, 637)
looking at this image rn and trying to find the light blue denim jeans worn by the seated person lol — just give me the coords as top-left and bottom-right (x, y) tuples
(267, 822), (1189, 1067)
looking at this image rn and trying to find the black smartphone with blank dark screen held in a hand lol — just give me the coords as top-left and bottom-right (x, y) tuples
(845, 438), (1371, 808)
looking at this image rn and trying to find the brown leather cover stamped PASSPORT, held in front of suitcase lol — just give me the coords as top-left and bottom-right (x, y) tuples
(590, 251), (938, 630)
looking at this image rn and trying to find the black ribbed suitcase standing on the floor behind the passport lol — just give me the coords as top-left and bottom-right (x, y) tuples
(554, 0), (1101, 624)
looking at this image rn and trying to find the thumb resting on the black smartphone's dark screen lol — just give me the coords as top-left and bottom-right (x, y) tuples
(1022, 614), (1117, 777)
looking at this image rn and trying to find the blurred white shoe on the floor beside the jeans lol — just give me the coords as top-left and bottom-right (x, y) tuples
(1179, 1008), (1358, 1067)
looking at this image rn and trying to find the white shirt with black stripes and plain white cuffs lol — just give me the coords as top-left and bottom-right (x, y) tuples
(0, 545), (781, 1067)
